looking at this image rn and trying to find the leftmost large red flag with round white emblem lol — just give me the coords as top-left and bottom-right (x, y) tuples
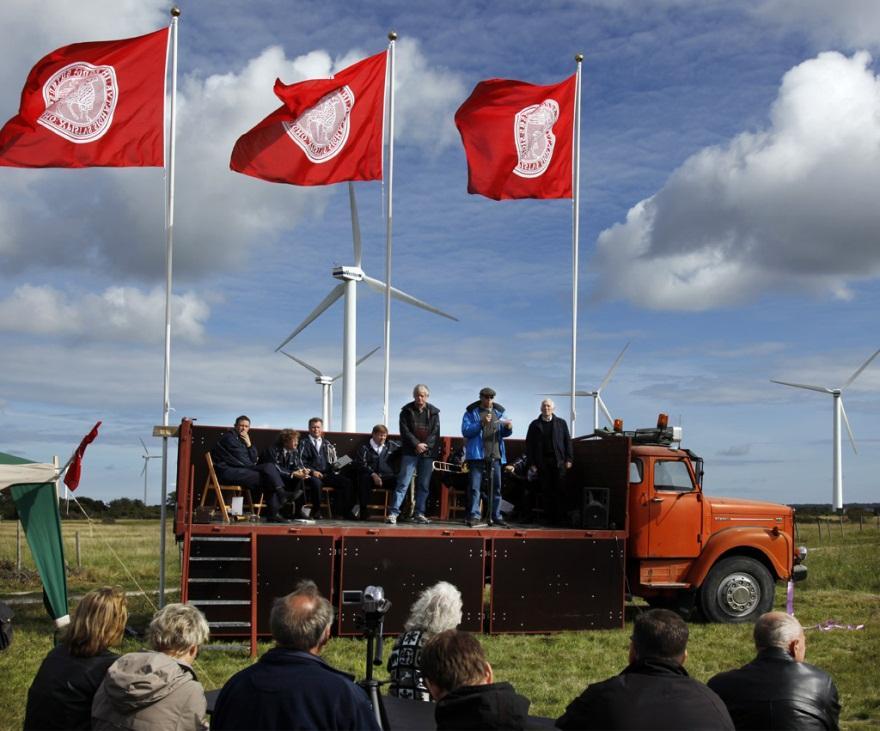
(0, 28), (168, 168)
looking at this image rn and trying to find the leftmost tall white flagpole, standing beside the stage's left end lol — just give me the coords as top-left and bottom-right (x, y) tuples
(159, 7), (180, 609)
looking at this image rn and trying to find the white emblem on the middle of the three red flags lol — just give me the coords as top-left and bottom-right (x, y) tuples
(283, 86), (354, 163)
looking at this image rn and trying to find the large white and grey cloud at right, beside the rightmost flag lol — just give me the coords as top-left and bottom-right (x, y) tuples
(597, 52), (880, 310)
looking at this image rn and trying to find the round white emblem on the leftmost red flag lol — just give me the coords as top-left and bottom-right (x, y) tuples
(37, 61), (119, 143)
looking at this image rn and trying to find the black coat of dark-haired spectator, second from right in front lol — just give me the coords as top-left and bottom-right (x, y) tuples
(556, 658), (733, 731)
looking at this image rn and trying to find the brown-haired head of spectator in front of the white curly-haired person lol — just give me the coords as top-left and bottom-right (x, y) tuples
(420, 629), (490, 694)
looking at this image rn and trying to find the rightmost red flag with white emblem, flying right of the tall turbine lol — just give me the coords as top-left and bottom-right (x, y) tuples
(455, 75), (576, 200)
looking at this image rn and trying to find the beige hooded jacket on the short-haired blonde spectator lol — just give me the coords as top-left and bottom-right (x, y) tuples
(92, 651), (208, 731)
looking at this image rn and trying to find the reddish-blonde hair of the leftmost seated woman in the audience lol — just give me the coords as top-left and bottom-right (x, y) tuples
(61, 587), (128, 657)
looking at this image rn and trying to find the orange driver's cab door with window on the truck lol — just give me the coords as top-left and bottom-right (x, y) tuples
(642, 459), (703, 558)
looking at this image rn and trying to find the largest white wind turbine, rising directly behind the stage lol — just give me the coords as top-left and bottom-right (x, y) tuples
(275, 183), (458, 432)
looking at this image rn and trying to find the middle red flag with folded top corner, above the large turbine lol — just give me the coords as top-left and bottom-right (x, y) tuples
(229, 51), (387, 185)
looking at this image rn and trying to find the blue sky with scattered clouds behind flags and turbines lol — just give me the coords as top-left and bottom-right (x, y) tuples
(0, 0), (880, 502)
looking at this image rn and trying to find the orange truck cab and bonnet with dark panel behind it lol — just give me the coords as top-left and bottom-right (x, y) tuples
(572, 414), (807, 622)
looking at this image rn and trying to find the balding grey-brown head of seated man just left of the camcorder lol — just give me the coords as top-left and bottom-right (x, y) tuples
(269, 579), (333, 652)
